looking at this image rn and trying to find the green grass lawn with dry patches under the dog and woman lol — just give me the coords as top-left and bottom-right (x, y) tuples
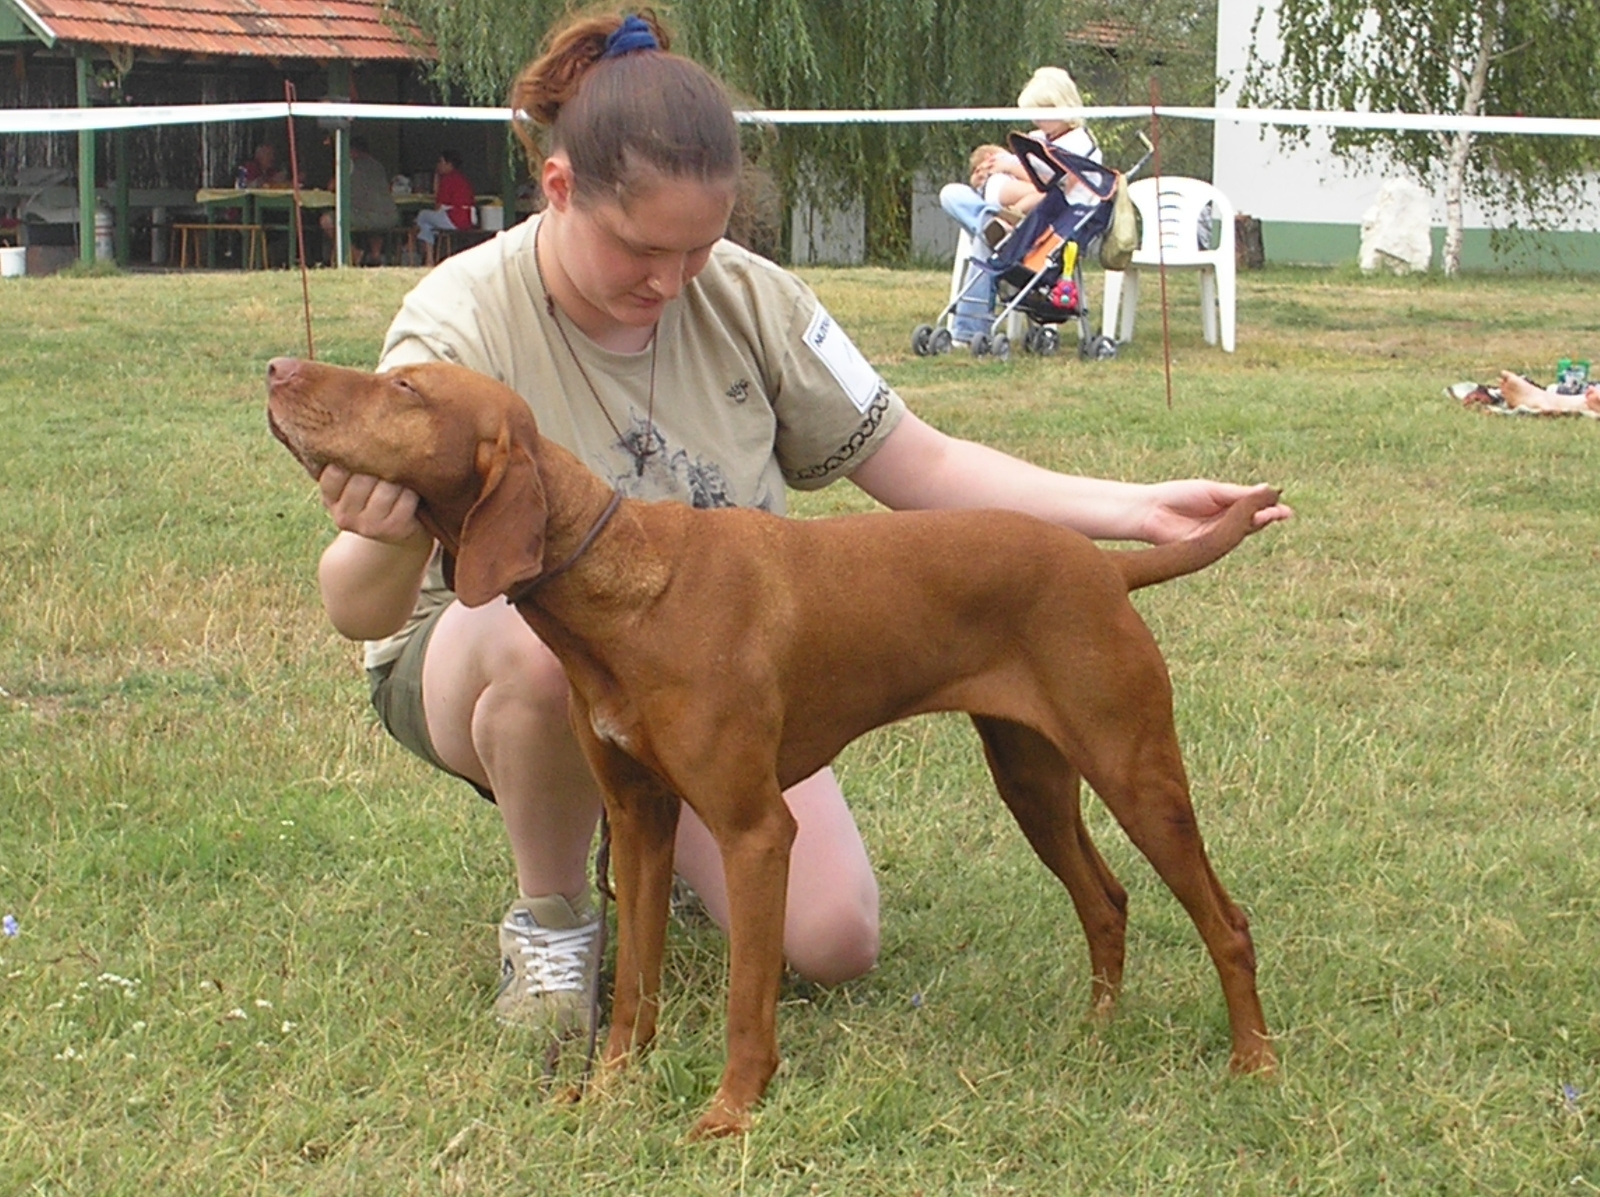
(0, 270), (1600, 1197)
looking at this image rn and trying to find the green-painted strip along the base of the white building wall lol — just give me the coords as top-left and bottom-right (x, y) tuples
(1261, 221), (1600, 274)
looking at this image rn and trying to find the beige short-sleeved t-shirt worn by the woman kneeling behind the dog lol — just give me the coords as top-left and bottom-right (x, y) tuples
(366, 209), (906, 667)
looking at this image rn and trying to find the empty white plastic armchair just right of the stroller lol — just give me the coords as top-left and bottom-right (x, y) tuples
(1101, 178), (1235, 354)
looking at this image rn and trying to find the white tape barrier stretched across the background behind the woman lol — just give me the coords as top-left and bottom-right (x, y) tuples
(9, 101), (1600, 138)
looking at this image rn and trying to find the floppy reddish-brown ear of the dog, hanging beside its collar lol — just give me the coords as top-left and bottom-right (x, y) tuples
(454, 426), (546, 607)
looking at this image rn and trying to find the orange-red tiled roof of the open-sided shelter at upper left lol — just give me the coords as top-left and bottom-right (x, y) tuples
(20, 0), (434, 61)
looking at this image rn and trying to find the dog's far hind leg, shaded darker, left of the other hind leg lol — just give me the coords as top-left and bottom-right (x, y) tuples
(973, 715), (1128, 1016)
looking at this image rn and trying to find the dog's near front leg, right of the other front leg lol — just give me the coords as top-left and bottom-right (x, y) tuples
(691, 776), (795, 1138)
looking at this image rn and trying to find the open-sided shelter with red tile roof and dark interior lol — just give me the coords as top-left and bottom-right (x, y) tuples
(0, 0), (457, 261)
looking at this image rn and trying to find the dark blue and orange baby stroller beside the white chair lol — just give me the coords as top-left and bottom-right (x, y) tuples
(910, 133), (1142, 360)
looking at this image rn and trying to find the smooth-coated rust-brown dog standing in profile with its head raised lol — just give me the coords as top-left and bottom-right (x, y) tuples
(267, 358), (1277, 1135)
